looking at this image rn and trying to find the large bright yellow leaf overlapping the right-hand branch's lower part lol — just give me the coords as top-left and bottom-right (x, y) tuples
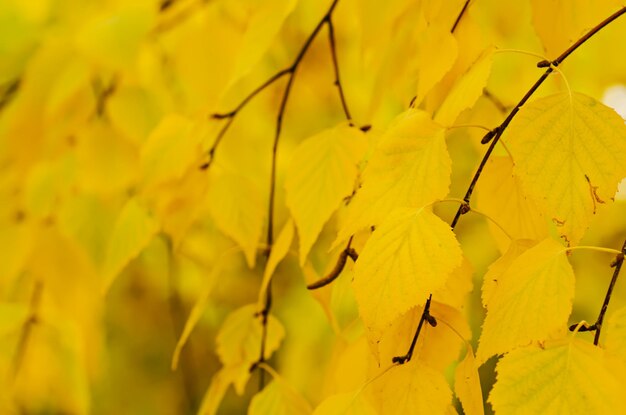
(353, 208), (462, 342)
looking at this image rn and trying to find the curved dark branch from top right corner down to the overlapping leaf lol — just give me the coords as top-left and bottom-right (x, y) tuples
(451, 7), (626, 229)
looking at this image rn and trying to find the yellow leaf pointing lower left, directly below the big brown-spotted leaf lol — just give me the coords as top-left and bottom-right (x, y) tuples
(476, 239), (575, 363)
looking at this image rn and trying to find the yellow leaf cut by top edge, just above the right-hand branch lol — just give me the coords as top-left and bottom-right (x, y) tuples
(530, 0), (621, 59)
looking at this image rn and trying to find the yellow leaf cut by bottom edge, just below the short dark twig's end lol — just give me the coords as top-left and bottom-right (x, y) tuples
(370, 359), (452, 415)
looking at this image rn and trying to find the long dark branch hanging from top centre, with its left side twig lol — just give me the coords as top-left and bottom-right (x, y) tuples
(254, 0), (339, 388)
